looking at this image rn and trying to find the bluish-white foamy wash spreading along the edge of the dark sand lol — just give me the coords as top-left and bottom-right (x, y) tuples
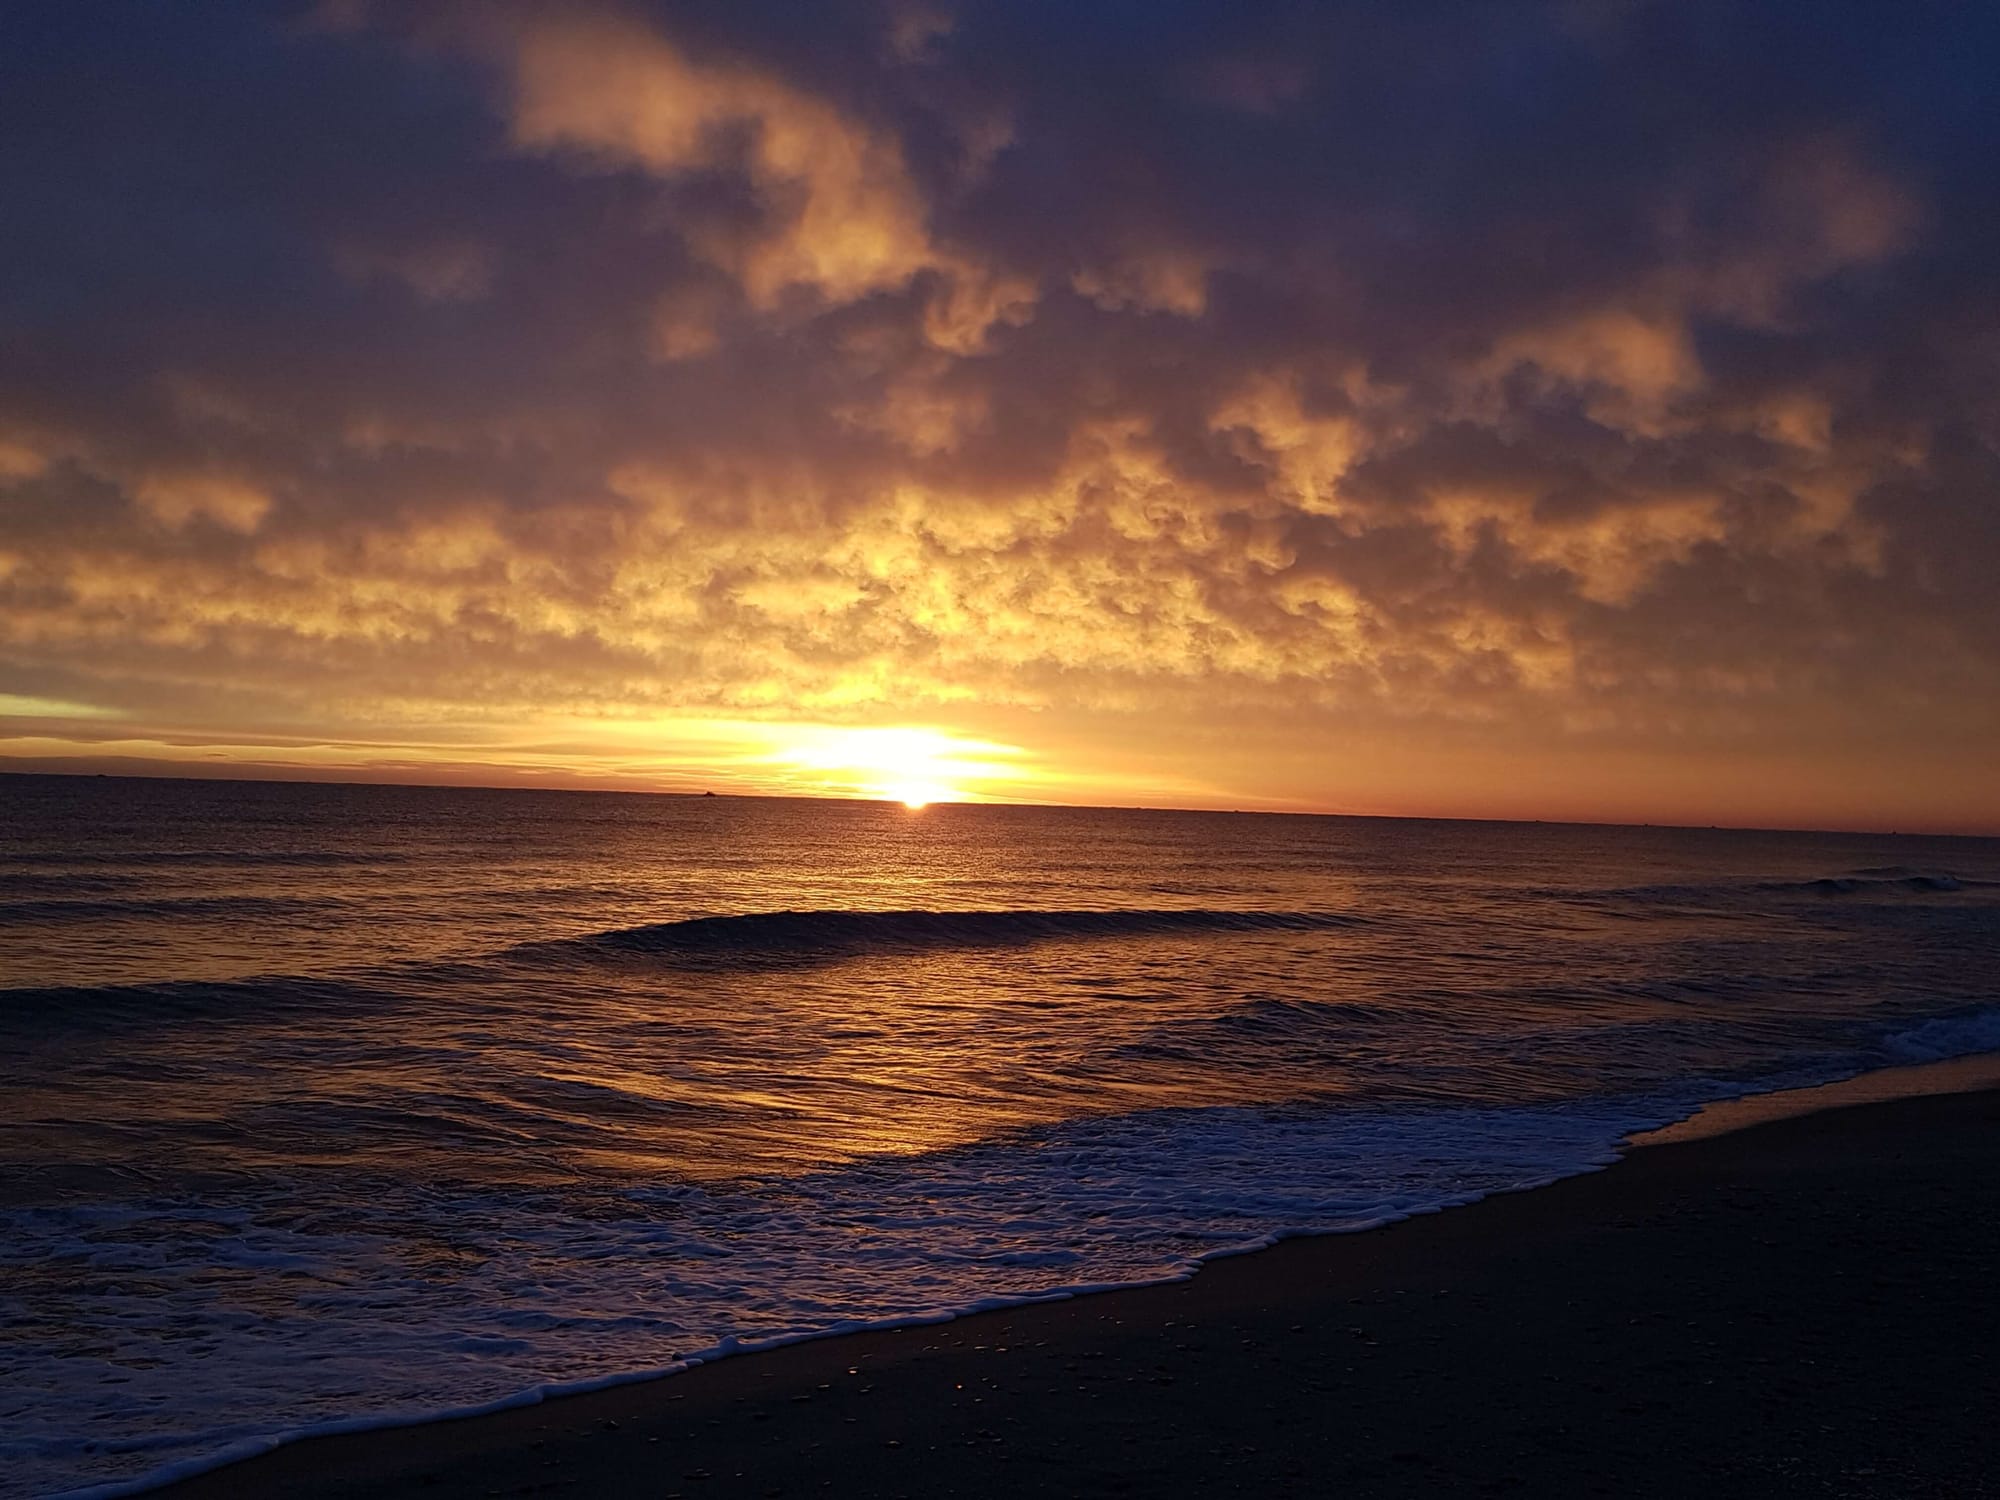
(11, 1096), (1672, 1500)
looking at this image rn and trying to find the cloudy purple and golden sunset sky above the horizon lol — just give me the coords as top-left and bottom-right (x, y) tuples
(0, 0), (2000, 832)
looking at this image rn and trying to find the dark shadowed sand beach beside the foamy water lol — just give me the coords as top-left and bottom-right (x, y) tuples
(166, 1092), (2000, 1500)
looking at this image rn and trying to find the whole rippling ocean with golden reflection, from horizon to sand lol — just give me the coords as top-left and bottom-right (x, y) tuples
(0, 776), (2000, 1496)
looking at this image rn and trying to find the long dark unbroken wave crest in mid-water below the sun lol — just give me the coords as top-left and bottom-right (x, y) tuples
(512, 910), (1360, 966)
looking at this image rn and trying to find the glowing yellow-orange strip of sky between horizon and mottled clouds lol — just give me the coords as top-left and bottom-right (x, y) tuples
(11, 716), (2000, 834)
